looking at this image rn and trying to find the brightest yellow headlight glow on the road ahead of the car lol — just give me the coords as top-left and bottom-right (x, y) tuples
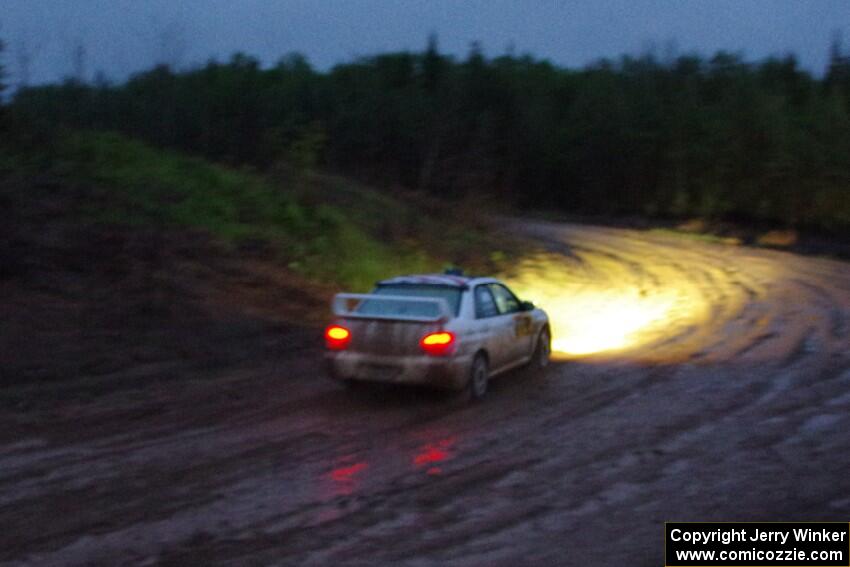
(505, 253), (709, 358)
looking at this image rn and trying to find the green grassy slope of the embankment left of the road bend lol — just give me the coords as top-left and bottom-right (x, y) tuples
(0, 133), (505, 291)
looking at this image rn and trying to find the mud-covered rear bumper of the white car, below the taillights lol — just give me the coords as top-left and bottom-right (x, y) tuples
(325, 352), (472, 390)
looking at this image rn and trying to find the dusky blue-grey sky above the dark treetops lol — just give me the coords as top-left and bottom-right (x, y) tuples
(0, 0), (850, 84)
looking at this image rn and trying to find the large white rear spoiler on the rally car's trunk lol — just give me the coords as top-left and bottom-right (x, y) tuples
(331, 293), (452, 323)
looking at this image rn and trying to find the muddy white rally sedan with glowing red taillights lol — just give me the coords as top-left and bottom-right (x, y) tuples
(325, 272), (551, 399)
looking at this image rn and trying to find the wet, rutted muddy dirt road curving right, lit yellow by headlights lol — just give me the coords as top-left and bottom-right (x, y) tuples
(0, 223), (850, 566)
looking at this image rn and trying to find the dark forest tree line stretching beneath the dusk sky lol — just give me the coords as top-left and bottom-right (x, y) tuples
(4, 37), (850, 233)
